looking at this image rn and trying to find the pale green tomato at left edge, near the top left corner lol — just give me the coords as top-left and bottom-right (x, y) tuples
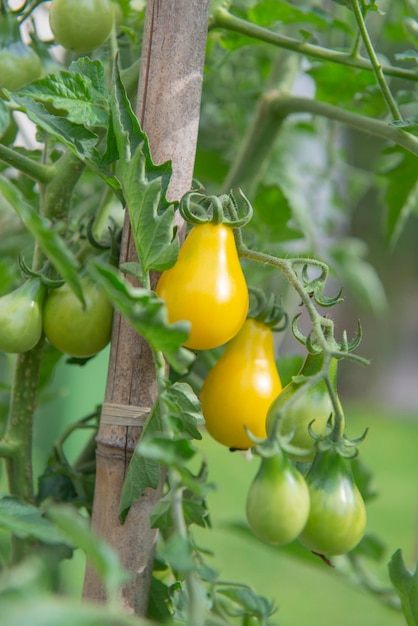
(0, 41), (42, 91)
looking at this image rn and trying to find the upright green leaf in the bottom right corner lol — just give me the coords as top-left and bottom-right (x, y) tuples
(389, 550), (418, 626)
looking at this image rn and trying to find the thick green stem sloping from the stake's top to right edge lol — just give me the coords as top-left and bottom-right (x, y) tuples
(210, 8), (418, 82)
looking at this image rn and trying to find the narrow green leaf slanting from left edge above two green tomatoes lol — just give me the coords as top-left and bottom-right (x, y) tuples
(0, 176), (84, 303)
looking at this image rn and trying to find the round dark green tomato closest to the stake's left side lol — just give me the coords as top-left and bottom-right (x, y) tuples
(43, 277), (113, 358)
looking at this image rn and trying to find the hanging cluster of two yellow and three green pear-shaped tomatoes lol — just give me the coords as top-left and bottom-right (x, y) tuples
(156, 202), (366, 556)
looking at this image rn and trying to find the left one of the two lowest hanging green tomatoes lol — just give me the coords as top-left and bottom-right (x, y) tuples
(246, 452), (309, 545)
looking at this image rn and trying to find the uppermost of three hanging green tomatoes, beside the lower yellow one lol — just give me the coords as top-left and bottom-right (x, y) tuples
(267, 353), (344, 461)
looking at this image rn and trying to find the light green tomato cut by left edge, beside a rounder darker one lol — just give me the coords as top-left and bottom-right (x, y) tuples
(0, 278), (46, 354)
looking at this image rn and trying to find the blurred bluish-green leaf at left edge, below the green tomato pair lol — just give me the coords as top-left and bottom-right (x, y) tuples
(0, 494), (70, 546)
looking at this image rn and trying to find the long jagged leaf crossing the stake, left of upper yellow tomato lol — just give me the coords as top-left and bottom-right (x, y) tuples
(112, 66), (178, 273)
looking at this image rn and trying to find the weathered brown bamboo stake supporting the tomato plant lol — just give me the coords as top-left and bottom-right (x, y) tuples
(84, 0), (209, 615)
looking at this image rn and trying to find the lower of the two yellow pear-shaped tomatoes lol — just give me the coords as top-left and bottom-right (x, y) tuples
(200, 318), (282, 450)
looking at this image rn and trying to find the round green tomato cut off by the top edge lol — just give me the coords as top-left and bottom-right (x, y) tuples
(49, 0), (115, 54)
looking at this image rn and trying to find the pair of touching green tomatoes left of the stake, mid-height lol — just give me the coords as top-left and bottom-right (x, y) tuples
(0, 277), (113, 358)
